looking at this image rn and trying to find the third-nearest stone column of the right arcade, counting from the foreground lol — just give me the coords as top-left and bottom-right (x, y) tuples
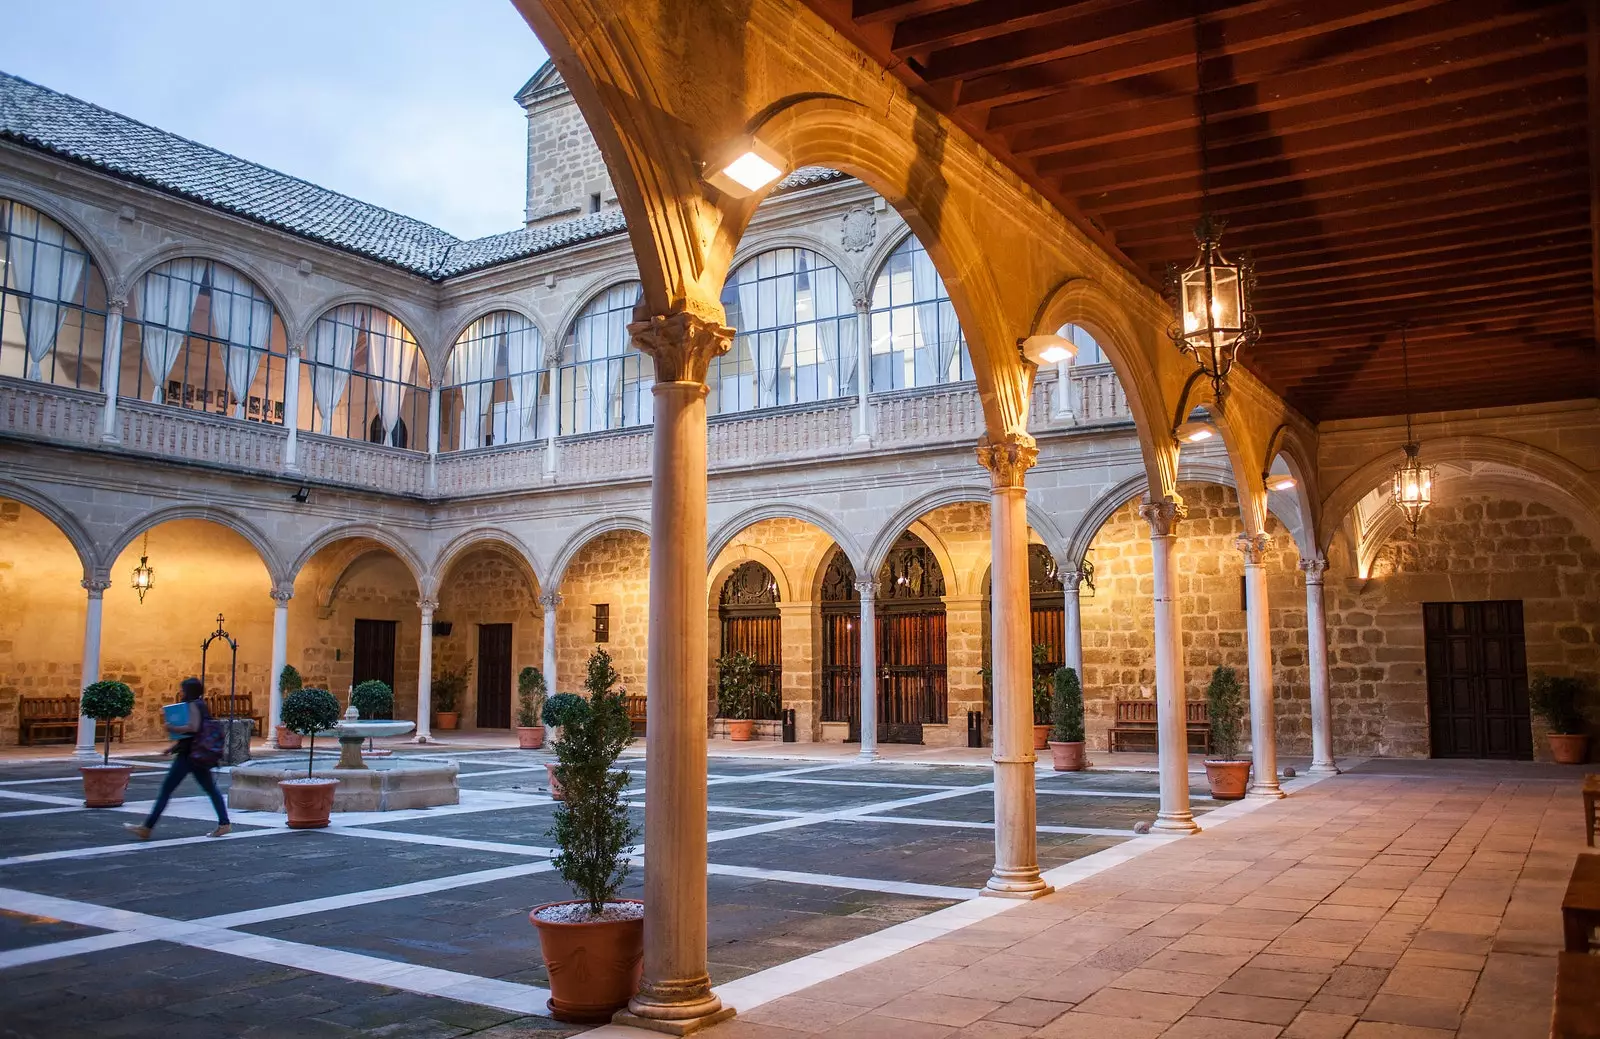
(1139, 498), (1200, 832)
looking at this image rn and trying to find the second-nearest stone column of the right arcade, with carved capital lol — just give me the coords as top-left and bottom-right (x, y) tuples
(978, 432), (1054, 898)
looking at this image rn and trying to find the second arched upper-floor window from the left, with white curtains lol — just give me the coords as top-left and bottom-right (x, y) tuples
(118, 259), (288, 424)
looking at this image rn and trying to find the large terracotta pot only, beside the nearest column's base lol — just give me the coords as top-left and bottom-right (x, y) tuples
(528, 898), (645, 1025)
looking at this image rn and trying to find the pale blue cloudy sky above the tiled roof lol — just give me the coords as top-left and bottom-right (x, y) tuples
(0, 0), (544, 239)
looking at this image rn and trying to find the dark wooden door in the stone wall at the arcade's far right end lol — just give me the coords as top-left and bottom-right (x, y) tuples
(1422, 599), (1533, 760)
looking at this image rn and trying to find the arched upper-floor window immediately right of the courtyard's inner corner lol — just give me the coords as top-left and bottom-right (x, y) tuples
(438, 311), (550, 451)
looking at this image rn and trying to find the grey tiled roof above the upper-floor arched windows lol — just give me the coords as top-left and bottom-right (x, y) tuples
(0, 72), (843, 280)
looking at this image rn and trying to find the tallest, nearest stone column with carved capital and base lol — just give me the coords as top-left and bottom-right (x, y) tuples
(618, 311), (733, 1034)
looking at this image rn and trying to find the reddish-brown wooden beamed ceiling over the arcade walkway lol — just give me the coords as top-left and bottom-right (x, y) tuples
(806, 0), (1600, 419)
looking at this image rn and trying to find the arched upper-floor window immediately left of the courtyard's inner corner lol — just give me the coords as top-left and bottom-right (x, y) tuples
(299, 303), (427, 450)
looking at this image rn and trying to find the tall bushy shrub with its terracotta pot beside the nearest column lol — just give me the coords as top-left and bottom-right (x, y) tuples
(528, 650), (645, 1025)
